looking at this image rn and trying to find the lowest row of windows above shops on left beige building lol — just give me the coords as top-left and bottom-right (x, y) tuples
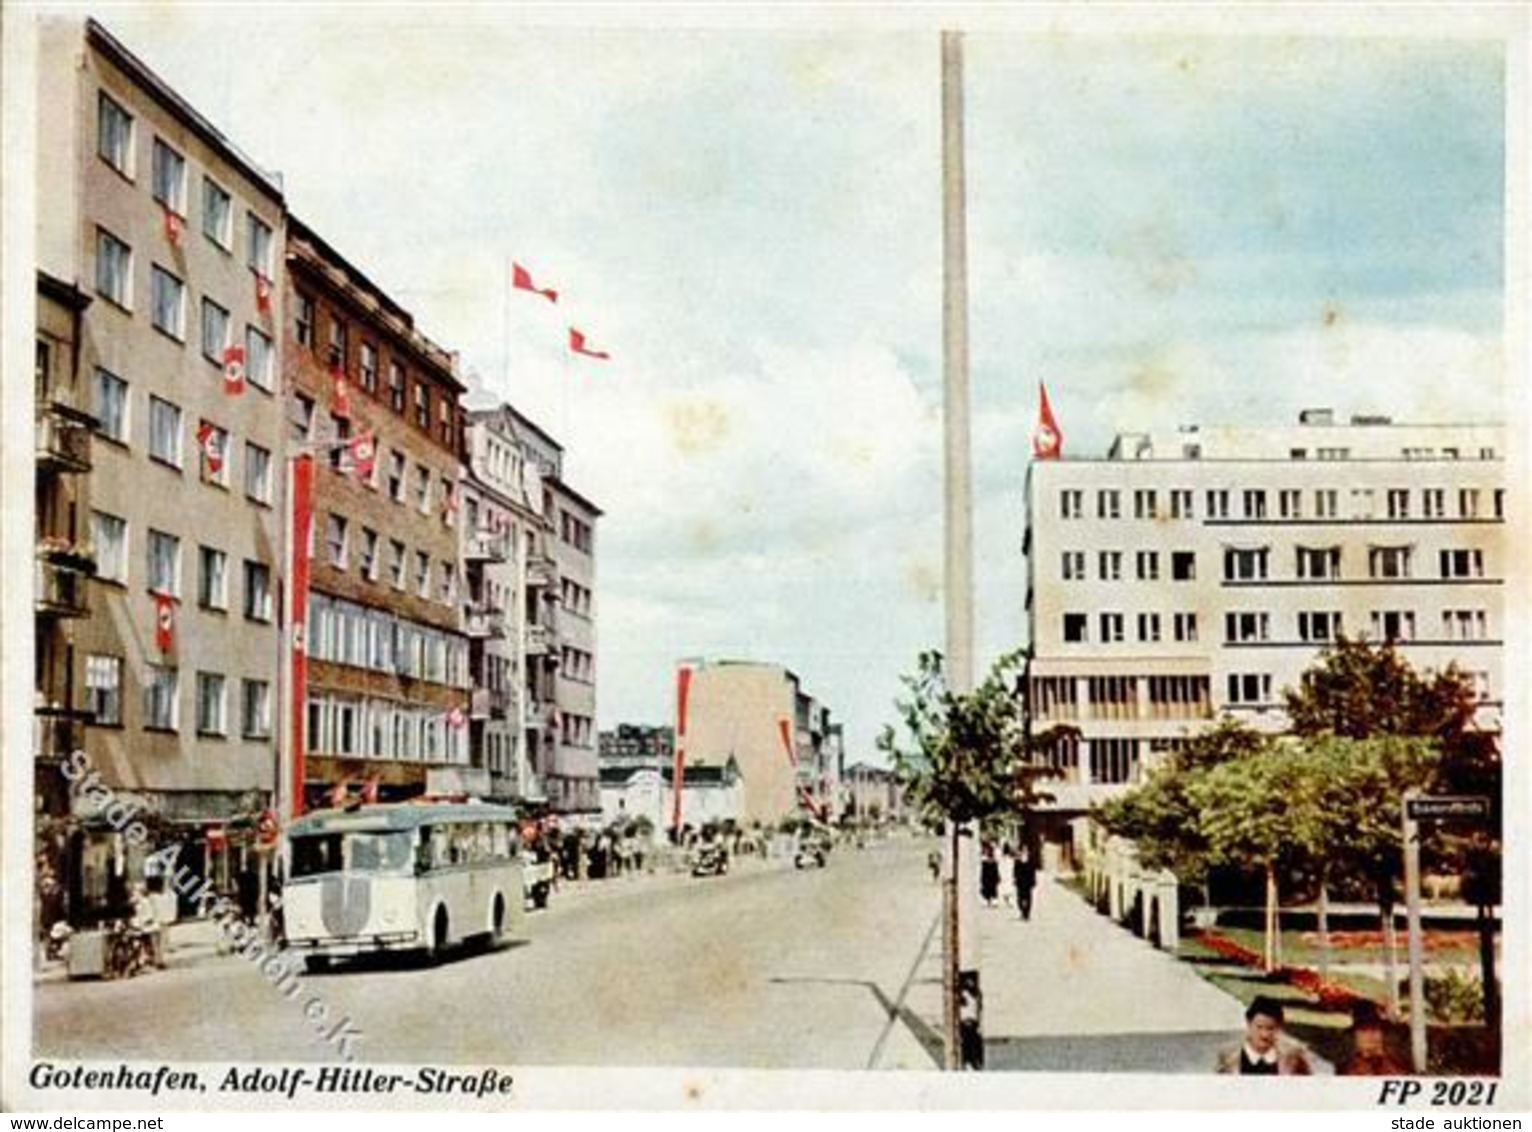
(86, 653), (271, 738)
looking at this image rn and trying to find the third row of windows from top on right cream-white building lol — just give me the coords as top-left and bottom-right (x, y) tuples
(1063, 608), (1489, 645)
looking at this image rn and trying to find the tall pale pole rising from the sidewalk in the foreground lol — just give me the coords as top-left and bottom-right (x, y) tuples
(942, 31), (977, 1069)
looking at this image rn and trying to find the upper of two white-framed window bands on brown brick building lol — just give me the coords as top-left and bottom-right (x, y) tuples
(308, 593), (469, 688)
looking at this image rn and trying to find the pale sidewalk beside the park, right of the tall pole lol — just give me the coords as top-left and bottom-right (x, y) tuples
(921, 878), (1244, 1074)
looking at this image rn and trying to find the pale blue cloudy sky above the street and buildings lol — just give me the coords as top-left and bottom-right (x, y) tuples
(29, 3), (1506, 761)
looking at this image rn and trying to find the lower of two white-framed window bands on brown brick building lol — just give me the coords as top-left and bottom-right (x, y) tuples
(308, 695), (469, 766)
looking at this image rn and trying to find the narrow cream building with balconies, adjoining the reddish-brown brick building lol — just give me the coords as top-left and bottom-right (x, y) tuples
(463, 406), (558, 804)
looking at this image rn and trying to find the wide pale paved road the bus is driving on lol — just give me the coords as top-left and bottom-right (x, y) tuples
(34, 841), (939, 1069)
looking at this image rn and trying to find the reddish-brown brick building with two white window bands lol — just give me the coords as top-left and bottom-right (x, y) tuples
(282, 218), (470, 804)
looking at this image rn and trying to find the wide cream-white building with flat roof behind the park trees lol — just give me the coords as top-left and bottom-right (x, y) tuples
(1025, 409), (1506, 863)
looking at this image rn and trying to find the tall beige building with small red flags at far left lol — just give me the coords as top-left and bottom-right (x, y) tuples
(37, 18), (283, 916)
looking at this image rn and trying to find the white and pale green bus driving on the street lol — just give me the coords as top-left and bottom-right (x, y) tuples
(282, 800), (524, 968)
